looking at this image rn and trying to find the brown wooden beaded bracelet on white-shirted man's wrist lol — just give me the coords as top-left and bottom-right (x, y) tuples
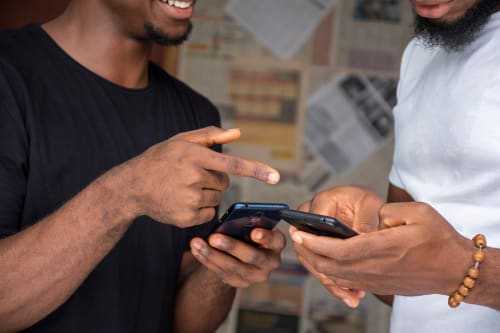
(448, 234), (486, 308)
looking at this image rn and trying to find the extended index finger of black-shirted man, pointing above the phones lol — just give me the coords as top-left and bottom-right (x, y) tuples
(201, 151), (280, 185)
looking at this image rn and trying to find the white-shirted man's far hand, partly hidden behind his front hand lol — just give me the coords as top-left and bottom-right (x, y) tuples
(290, 186), (384, 308)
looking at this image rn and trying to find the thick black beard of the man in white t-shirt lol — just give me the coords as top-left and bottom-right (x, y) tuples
(415, 0), (500, 52)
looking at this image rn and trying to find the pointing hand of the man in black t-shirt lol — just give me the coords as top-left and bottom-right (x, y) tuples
(114, 127), (280, 228)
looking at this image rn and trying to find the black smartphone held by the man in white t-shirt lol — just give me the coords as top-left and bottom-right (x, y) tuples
(281, 209), (358, 239)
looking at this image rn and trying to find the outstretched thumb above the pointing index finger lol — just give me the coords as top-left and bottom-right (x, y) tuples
(177, 126), (241, 147)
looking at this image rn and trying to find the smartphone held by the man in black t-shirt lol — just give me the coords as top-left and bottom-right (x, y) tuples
(214, 202), (290, 243)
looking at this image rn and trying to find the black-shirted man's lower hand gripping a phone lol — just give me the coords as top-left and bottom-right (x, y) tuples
(191, 229), (286, 288)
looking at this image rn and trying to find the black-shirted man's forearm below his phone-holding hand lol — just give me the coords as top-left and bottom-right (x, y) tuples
(174, 265), (236, 333)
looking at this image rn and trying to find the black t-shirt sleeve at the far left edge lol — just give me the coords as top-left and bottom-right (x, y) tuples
(0, 60), (27, 239)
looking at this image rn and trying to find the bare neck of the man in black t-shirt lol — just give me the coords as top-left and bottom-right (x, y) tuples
(43, 0), (152, 89)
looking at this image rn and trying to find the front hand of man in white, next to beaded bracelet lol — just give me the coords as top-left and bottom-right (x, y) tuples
(292, 202), (473, 296)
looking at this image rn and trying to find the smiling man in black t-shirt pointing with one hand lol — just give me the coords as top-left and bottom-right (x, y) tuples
(0, 0), (285, 332)
